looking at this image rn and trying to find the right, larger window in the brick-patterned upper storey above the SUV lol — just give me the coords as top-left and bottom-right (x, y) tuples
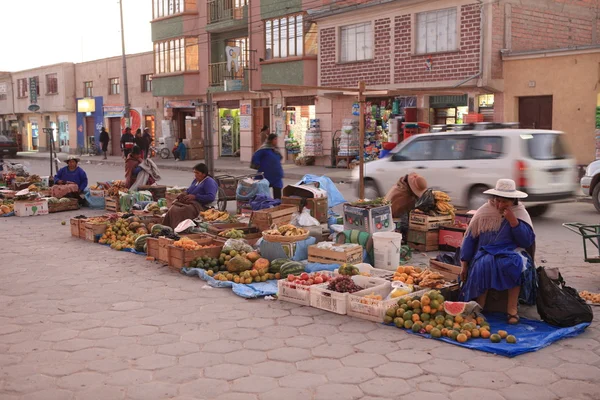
(416, 8), (458, 54)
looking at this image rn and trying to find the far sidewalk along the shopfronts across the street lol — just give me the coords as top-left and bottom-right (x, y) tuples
(12, 152), (352, 183)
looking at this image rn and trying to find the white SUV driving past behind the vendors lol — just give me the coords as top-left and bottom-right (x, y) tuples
(354, 129), (577, 216)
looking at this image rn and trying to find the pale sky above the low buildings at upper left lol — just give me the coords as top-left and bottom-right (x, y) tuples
(0, 0), (152, 72)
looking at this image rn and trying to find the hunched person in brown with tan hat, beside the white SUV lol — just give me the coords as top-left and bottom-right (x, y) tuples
(385, 172), (427, 238)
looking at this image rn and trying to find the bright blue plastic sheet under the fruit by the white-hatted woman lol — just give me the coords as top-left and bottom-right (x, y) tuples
(390, 314), (590, 357)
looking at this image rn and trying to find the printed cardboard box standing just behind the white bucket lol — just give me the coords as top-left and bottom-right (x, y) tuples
(344, 204), (395, 234)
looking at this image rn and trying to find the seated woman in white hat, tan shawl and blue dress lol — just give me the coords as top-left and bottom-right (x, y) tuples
(460, 179), (537, 324)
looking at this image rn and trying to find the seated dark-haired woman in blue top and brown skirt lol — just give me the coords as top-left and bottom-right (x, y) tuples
(163, 163), (219, 228)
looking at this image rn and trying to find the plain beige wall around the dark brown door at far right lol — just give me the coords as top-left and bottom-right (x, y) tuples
(504, 51), (600, 164)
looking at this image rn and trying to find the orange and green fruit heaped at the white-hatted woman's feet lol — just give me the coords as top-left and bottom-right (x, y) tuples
(384, 290), (517, 344)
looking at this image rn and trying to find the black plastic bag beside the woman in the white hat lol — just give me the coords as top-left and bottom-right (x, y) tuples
(536, 267), (594, 327)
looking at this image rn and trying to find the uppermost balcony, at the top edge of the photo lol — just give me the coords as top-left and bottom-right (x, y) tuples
(206, 0), (248, 33)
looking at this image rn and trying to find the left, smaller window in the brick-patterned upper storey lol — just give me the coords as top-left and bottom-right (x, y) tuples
(340, 22), (373, 62)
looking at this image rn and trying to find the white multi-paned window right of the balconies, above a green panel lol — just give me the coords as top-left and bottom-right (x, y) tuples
(265, 14), (305, 60)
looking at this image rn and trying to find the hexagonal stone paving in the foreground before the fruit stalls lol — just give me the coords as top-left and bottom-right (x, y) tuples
(0, 212), (600, 400)
